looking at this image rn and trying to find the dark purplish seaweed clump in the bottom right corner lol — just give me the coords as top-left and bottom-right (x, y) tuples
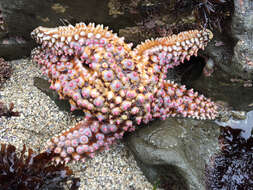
(206, 126), (253, 190)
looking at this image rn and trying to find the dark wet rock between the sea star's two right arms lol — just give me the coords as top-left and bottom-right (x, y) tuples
(182, 56), (253, 111)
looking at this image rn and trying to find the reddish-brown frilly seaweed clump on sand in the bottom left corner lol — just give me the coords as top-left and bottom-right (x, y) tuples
(0, 144), (79, 190)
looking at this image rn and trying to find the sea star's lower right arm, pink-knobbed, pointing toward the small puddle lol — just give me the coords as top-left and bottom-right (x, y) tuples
(156, 80), (217, 119)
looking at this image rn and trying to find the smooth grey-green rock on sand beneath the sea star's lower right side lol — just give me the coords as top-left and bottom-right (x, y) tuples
(126, 118), (219, 190)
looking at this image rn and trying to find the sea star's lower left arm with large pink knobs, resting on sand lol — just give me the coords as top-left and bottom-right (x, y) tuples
(47, 118), (130, 162)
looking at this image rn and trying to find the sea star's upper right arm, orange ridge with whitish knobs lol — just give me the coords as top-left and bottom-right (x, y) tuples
(133, 29), (213, 73)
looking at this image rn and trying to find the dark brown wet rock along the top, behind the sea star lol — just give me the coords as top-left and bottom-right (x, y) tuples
(0, 0), (233, 59)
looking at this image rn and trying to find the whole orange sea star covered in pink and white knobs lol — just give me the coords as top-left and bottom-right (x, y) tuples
(31, 23), (217, 161)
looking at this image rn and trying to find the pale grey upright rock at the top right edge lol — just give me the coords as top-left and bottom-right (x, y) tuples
(232, 0), (253, 79)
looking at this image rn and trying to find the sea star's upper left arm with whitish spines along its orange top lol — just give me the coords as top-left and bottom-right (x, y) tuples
(31, 23), (132, 66)
